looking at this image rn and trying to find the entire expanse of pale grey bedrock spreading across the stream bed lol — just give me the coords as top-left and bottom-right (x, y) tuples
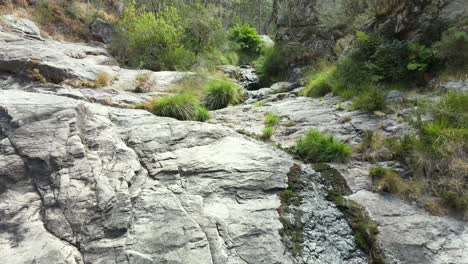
(0, 14), (468, 264)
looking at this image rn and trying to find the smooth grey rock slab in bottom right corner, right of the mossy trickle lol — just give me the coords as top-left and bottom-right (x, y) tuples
(349, 190), (468, 264)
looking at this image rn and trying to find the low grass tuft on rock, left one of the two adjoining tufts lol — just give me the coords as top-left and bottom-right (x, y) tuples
(151, 94), (199, 120)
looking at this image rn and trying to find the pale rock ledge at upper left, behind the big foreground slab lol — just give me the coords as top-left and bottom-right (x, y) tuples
(0, 16), (194, 92)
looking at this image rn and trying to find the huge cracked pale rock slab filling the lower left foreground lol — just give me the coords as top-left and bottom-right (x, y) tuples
(0, 90), (294, 264)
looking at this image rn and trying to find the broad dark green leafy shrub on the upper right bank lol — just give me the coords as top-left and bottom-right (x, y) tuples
(336, 32), (435, 92)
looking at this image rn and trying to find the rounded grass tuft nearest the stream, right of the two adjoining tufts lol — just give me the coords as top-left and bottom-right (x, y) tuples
(203, 80), (243, 110)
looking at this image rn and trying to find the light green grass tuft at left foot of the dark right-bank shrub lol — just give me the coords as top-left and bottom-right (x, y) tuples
(302, 65), (336, 97)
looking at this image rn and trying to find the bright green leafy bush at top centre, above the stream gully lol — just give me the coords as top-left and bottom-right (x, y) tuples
(229, 24), (264, 54)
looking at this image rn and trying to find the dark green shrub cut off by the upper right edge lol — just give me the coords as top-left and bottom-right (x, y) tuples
(435, 27), (468, 70)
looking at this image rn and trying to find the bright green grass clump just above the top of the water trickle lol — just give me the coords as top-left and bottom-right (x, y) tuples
(295, 130), (352, 162)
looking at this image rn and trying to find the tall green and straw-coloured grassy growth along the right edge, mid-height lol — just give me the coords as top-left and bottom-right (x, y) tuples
(392, 92), (468, 218)
